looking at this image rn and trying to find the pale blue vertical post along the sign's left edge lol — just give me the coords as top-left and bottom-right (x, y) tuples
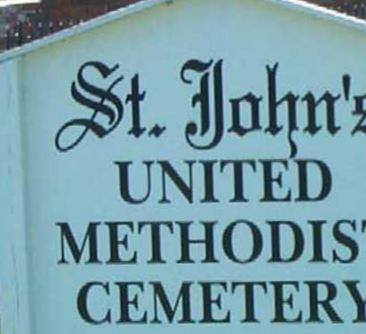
(0, 59), (29, 334)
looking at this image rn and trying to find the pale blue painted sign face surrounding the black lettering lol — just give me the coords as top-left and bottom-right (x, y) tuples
(0, 0), (366, 334)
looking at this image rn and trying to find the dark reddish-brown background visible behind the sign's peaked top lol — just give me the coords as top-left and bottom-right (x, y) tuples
(0, 0), (366, 51)
